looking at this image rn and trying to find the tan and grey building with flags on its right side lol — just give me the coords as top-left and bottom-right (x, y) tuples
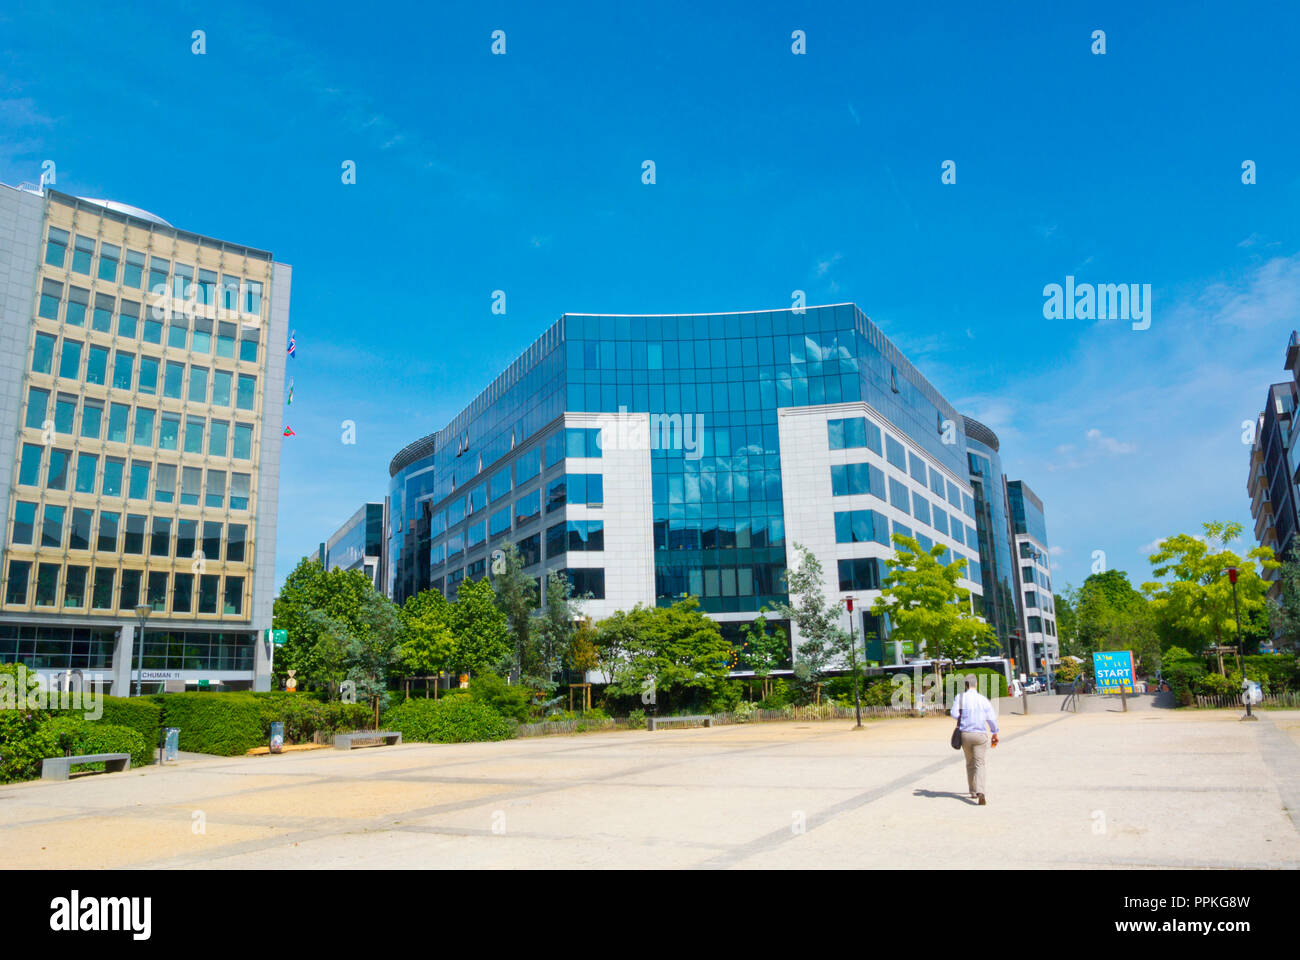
(0, 180), (290, 695)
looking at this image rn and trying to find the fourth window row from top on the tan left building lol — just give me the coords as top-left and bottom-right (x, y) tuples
(23, 386), (252, 460)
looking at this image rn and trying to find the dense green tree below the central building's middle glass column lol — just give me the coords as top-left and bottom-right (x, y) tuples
(597, 597), (732, 701)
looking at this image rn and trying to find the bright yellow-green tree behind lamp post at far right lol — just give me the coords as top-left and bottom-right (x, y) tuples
(1143, 522), (1279, 652)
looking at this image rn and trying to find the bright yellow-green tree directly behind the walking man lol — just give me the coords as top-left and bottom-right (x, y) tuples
(871, 533), (996, 689)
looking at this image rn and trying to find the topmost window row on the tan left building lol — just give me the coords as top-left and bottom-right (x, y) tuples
(46, 226), (261, 315)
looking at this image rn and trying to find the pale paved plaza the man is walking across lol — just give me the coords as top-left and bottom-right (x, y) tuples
(0, 697), (1300, 869)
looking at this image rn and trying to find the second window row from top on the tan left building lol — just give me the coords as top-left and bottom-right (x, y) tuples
(36, 280), (261, 363)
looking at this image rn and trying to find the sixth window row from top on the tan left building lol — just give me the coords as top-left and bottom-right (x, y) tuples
(10, 509), (248, 563)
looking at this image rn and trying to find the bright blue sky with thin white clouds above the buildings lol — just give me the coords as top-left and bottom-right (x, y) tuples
(0, 0), (1300, 587)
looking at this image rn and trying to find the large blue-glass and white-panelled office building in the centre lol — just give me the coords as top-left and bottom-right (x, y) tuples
(387, 304), (983, 666)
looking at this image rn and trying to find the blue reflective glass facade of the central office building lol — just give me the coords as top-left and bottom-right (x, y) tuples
(389, 304), (967, 614)
